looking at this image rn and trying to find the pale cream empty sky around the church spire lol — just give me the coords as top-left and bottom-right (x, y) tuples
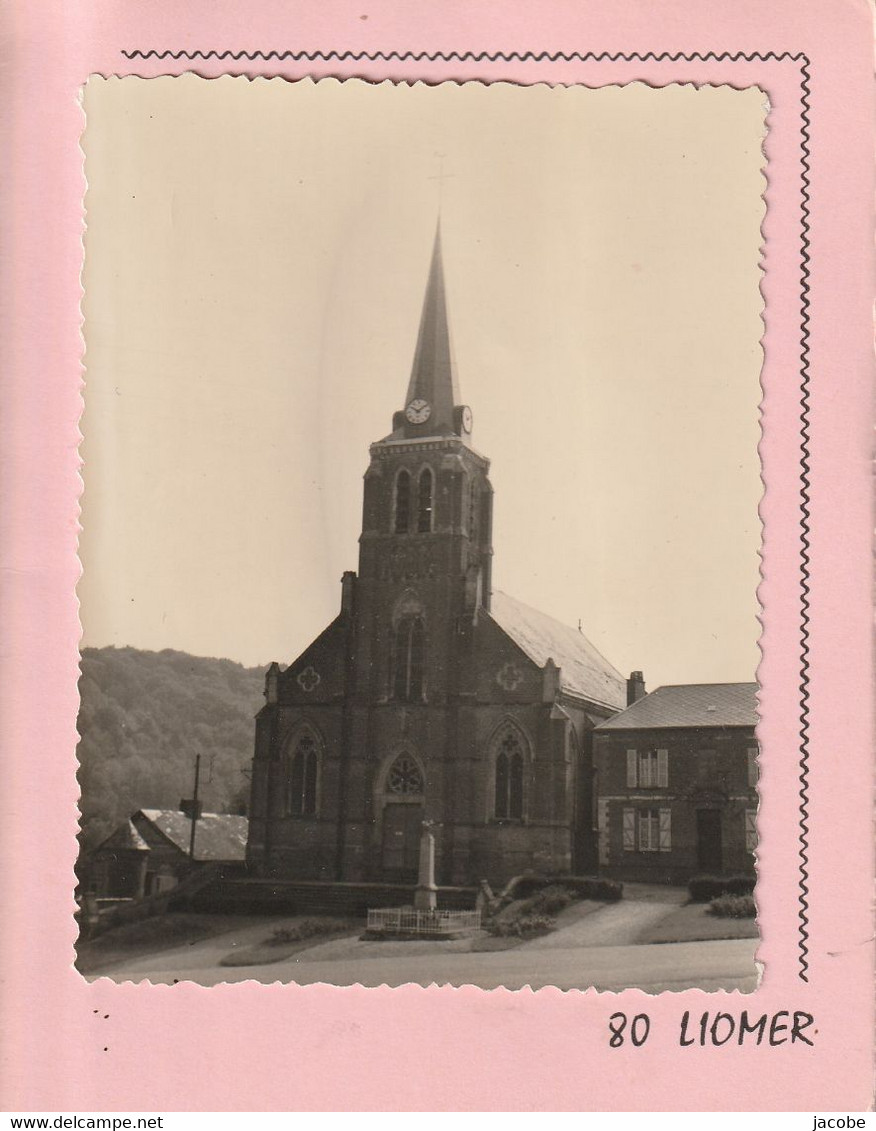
(79, 75), (766, 688)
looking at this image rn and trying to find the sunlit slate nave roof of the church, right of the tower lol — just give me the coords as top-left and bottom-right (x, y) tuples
(489, 590), (626, 708)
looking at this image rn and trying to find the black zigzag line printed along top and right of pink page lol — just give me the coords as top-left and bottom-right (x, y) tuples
(121, 49), (812, 982)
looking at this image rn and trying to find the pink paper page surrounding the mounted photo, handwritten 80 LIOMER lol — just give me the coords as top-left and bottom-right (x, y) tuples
(0, 0), (873, 1111)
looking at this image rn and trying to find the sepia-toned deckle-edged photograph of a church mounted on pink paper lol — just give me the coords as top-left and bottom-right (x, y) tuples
(76, 75), (769, 993)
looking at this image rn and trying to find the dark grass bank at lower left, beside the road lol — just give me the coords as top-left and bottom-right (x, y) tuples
(76, 912), (258, 974)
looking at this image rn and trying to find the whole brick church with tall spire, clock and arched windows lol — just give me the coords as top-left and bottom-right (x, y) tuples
(246, 228), (644, 886)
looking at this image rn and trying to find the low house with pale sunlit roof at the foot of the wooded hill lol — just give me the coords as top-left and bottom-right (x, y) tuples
(88, 809), (249, 899)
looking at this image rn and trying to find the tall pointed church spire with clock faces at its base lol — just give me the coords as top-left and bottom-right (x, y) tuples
(405, 219), (460, 435)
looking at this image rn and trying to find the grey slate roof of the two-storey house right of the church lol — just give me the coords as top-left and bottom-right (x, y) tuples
(597, 683), (757, 731)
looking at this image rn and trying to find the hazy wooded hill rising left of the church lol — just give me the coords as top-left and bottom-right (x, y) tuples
(78, 648), (264, 849)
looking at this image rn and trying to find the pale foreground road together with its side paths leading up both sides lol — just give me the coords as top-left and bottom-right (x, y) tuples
(90, 884), (757, 993)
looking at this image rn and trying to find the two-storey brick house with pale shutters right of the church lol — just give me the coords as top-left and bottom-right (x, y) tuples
(593, 673), (757, 883)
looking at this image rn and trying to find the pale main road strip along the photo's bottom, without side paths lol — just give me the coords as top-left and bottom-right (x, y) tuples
(90, 939), (757, 993)
